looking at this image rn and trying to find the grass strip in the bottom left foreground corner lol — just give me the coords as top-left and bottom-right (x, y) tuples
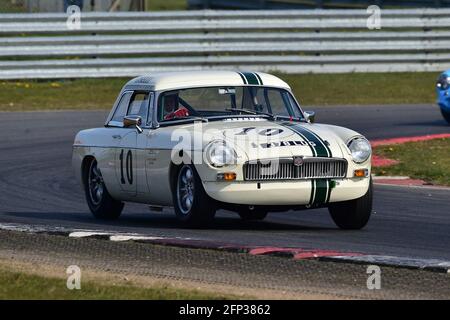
(0, 268), (236, 300)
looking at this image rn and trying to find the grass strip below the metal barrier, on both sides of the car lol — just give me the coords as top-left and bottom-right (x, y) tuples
(0, 73), (437, 111)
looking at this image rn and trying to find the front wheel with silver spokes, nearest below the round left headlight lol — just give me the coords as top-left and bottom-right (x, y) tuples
(172, 165), (216, 227)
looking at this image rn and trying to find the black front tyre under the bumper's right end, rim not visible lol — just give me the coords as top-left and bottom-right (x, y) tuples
(328, 179), (373, 230)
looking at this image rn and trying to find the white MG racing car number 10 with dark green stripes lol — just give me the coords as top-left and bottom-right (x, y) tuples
(73, 71), (372, 229)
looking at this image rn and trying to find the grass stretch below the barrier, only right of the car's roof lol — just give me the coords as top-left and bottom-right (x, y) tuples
(280, 72), (438, 105)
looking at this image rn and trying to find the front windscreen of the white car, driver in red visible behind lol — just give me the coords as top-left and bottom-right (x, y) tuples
(158, 86), (302, 122)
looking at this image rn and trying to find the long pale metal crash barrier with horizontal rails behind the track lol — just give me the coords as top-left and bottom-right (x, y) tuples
(0, 9), (450, 79)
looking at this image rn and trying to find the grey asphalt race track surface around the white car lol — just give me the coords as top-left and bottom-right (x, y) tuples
(0, 105), (450, 260)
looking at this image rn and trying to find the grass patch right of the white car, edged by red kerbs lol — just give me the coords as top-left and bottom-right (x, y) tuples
(373, 139), (450, 186)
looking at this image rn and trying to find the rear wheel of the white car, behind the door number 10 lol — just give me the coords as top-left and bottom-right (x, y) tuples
(83, 159), (124, 220)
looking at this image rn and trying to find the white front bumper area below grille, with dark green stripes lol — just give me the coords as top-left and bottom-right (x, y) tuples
(203, 178), (370, 206)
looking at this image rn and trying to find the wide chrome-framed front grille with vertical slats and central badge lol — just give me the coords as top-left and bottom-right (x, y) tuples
(244, 158), (347, 181)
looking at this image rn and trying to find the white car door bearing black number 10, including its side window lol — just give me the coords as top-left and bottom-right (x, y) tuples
(115, 91), (149, 200)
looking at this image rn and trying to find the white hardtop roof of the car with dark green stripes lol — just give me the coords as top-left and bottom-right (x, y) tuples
(124, 71), (290, 91)
